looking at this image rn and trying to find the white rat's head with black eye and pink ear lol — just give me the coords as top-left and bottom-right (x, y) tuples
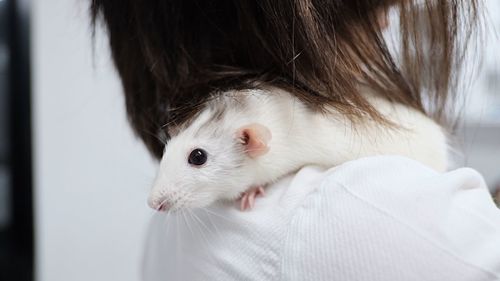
(149, 108), (271, 210)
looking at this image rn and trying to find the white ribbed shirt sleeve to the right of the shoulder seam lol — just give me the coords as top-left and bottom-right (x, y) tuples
(283, 156), (500, 280)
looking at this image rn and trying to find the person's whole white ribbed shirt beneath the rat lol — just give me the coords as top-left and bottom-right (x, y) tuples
(143, 156), (500, 281)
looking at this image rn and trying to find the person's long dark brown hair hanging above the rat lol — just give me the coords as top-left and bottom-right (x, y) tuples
(91, 0), (478, 158)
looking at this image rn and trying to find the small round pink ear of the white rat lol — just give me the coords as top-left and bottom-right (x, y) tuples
(236, 123), (271, 158)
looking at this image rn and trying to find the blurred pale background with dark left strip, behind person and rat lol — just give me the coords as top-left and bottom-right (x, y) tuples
(0, 0), (500, 281)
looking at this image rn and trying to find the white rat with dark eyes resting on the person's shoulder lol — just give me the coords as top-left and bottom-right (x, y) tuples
(149, 88), (447, 210)
